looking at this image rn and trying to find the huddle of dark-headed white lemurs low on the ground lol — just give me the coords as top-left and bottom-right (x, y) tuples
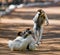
(8, 29), (35, 51)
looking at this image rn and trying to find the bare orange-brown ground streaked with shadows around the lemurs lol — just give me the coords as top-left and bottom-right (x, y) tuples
(0, 7), (60, 55)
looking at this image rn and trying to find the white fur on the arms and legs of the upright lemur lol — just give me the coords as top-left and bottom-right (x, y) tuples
(33, 10), (48, 44)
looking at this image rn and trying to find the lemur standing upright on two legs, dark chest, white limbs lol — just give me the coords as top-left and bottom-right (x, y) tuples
(33, 9), (49, 45)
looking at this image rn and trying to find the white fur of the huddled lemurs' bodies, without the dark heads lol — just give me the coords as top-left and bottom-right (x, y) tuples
(8, 35), (35, 51)
